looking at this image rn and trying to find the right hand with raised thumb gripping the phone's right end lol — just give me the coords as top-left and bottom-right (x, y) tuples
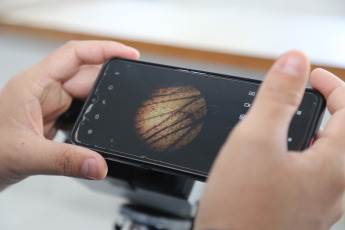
(195, 51), (345, 230)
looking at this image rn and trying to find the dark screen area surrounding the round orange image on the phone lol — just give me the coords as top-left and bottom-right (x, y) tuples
(75, 59), (315, 173)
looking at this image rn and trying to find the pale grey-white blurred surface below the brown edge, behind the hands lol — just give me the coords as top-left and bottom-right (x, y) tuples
(0, 27), (345, 230)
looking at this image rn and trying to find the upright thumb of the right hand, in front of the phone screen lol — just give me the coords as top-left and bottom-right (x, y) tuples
(246, 50), (310, 143)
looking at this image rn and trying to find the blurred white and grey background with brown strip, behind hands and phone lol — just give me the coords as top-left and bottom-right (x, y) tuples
(0, 0), (345, 230)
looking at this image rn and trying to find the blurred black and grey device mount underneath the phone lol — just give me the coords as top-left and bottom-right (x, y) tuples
(57, 100), (205, 230)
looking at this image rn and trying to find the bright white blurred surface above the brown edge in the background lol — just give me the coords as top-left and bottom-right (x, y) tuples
(0, 0), (345, 68)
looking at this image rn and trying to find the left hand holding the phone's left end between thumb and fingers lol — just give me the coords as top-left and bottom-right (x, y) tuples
(0, 41), (139, 191)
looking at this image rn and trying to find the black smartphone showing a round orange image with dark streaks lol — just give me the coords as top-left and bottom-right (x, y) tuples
(70, 58), (325, 181)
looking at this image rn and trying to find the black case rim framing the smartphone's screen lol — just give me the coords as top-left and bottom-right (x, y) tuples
(70, 58), (325, 181)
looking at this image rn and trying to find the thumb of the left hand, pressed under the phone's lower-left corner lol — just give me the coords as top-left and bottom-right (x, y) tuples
(27, 139), (108, 180)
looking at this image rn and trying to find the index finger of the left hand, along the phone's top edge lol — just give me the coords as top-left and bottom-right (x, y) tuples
(40, 41), (139, 81)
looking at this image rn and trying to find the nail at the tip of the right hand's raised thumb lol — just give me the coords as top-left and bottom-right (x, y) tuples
(276, 52), (307, 77)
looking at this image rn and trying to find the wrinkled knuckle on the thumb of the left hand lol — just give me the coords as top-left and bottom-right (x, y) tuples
(55, 149), (73, 176)
